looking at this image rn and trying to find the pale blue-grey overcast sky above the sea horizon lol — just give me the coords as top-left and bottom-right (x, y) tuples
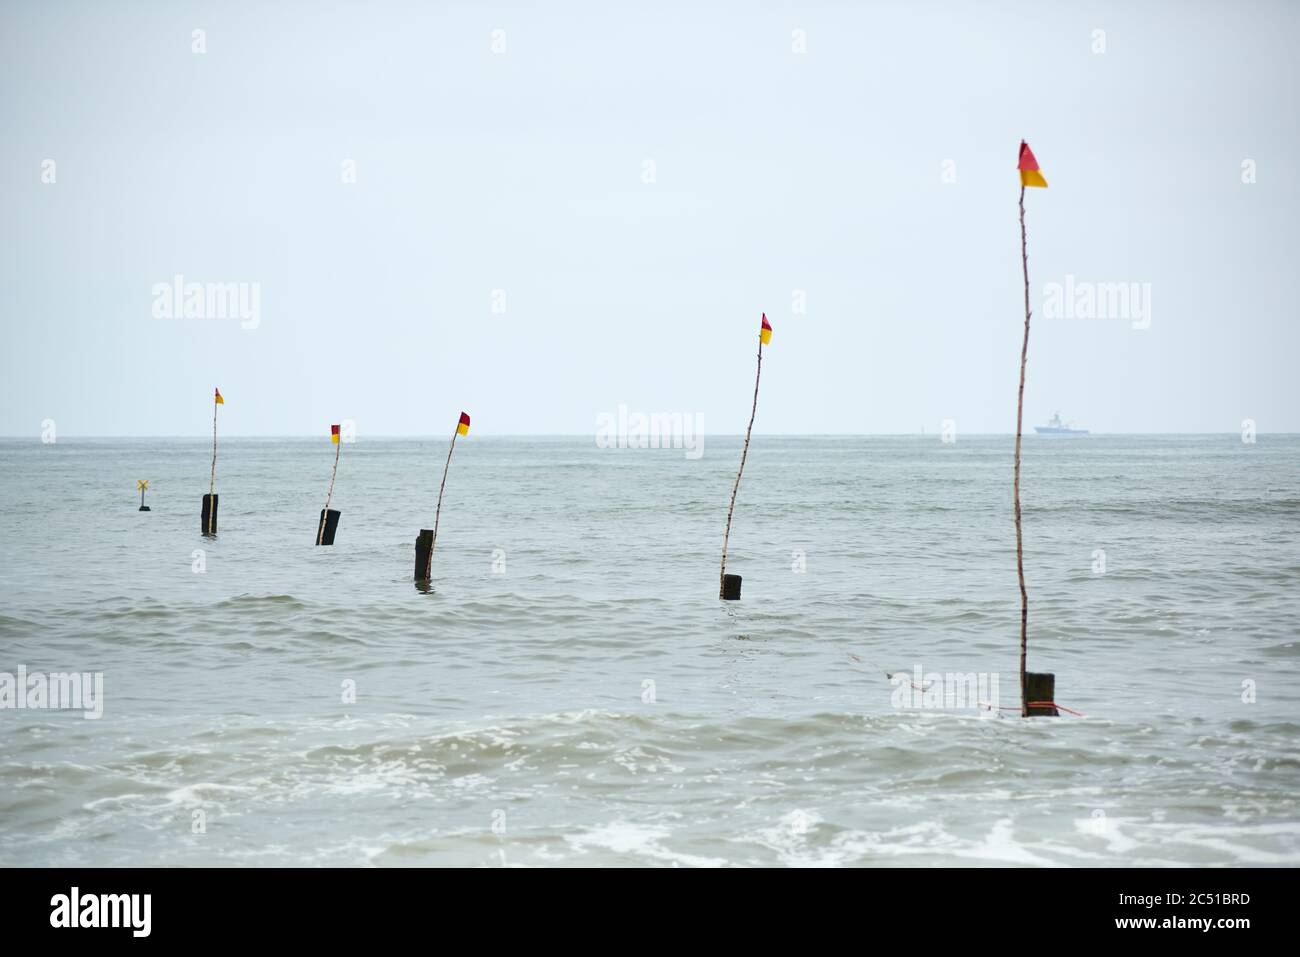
(0, 0), (1300, 439)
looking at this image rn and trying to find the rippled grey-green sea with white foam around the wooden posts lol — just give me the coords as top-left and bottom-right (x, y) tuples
(0, 436), (1300, 866)
